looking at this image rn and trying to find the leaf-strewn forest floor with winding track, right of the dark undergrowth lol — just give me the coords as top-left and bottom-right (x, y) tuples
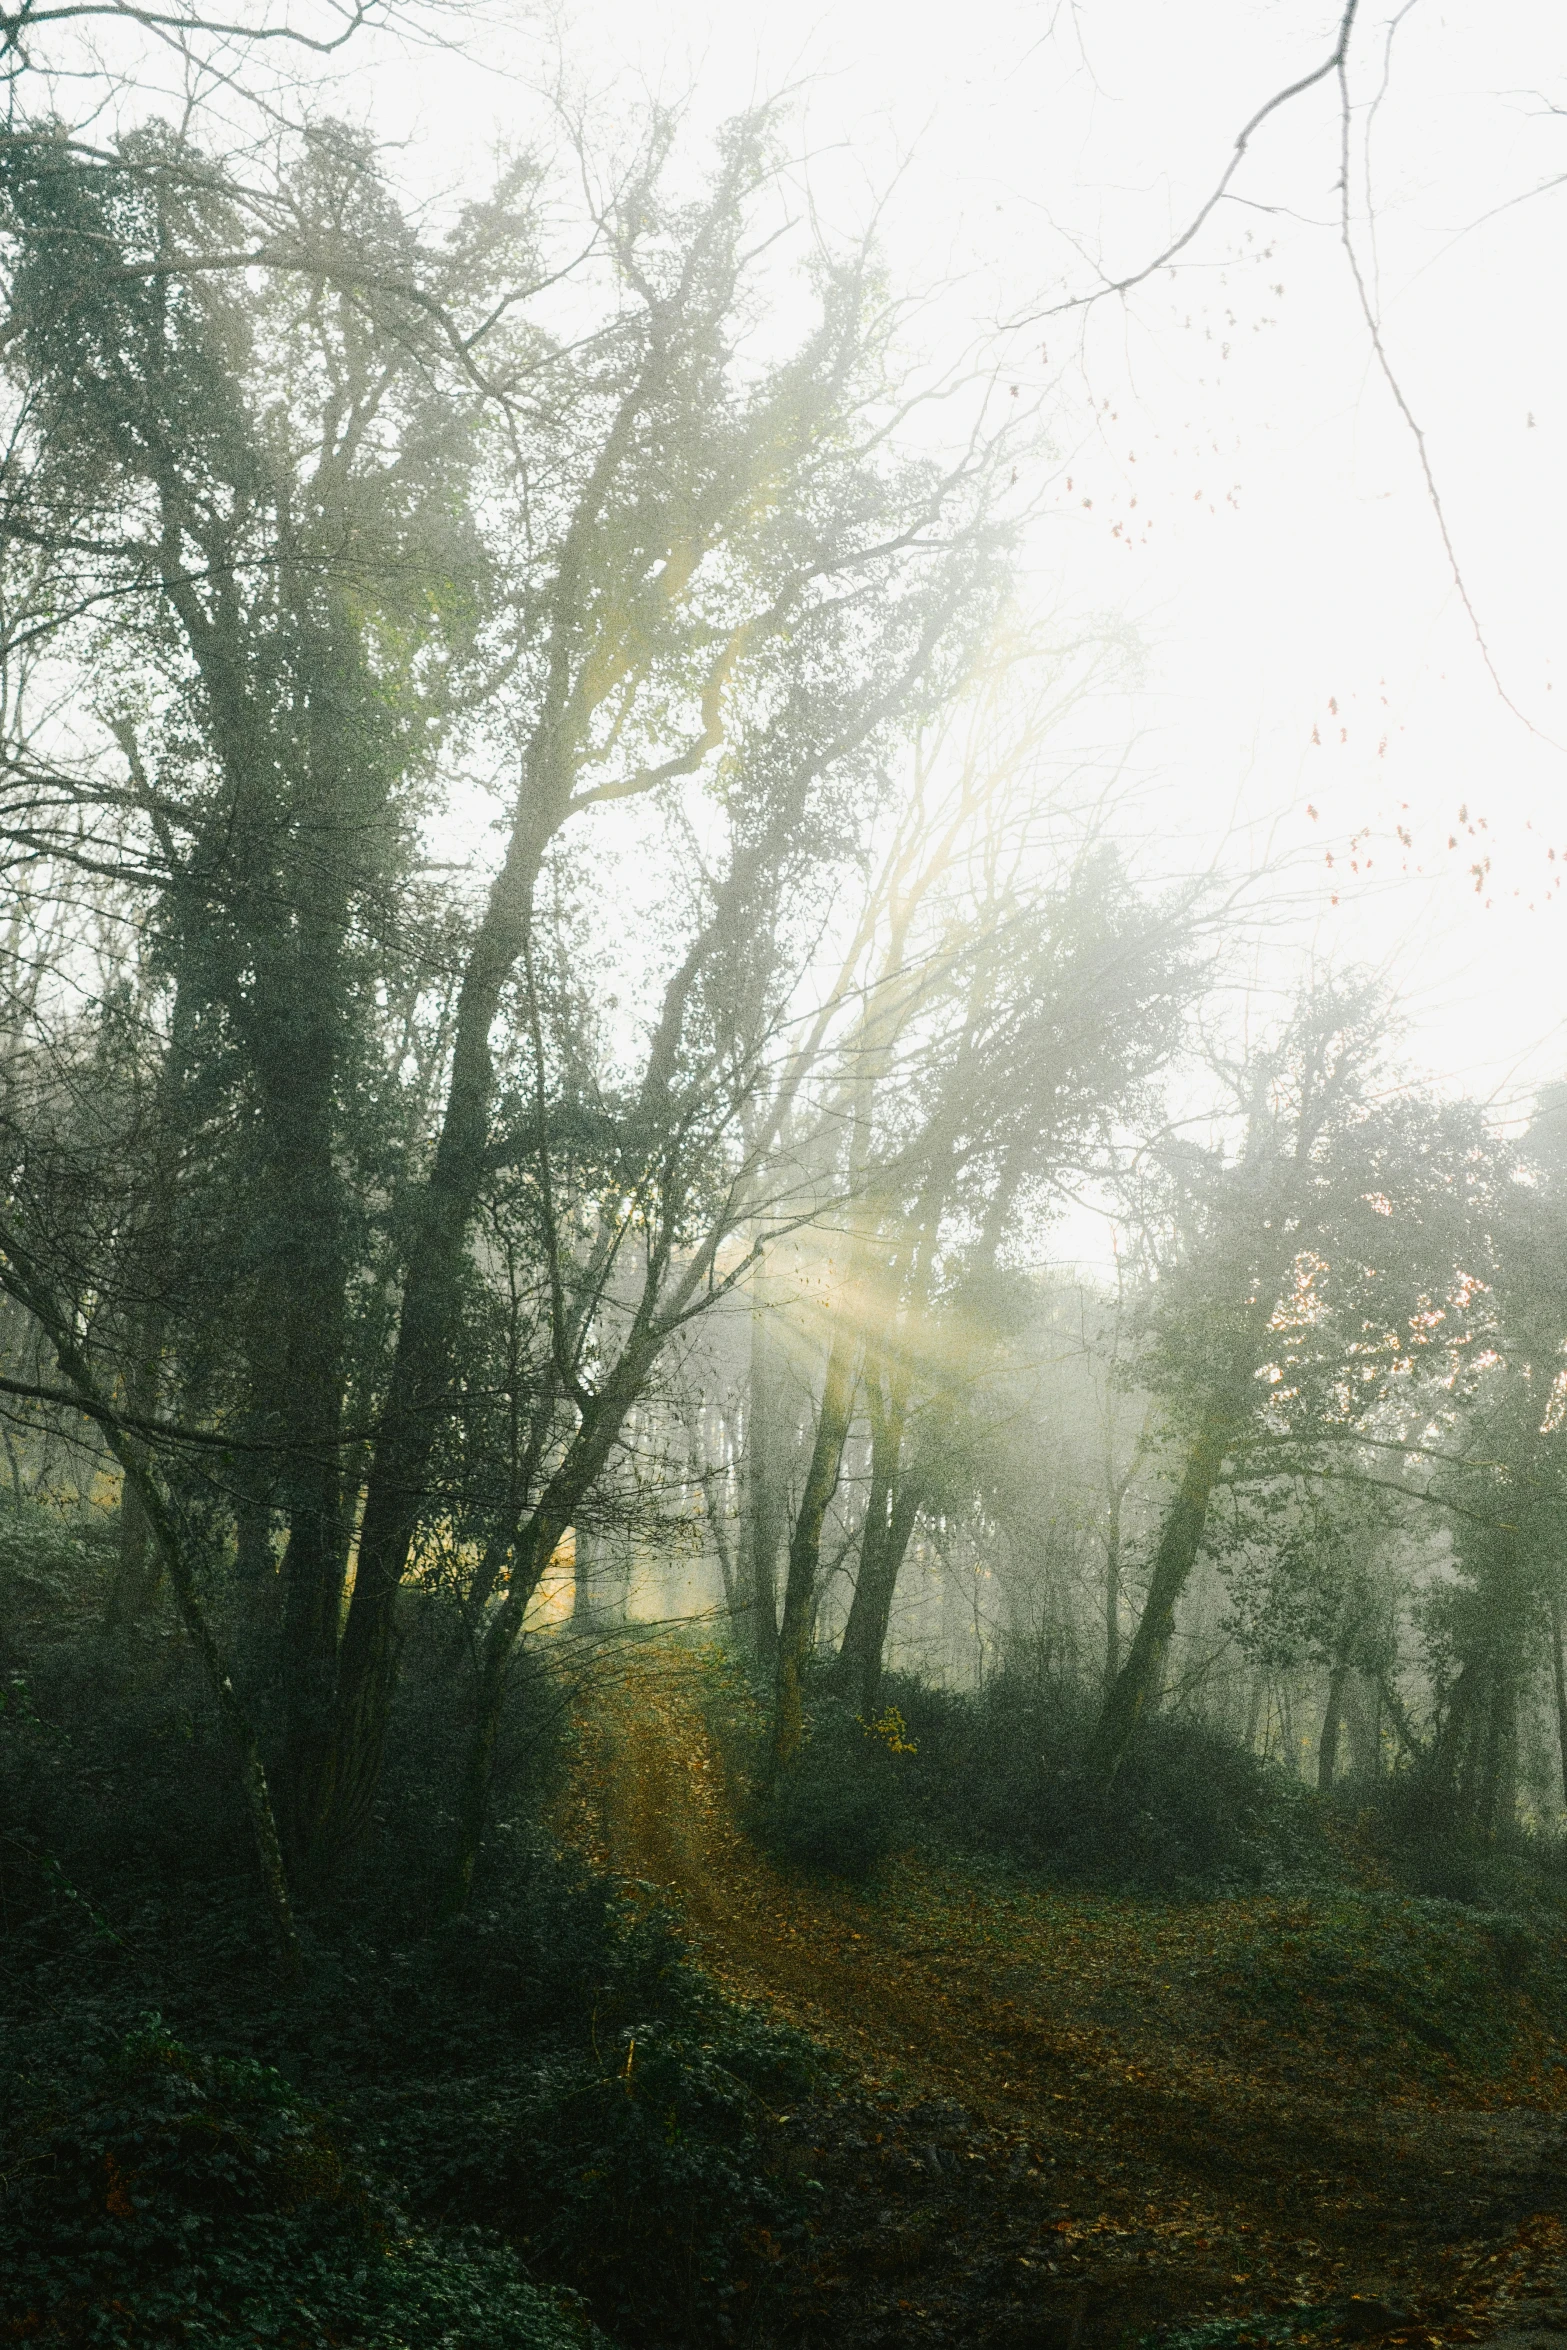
(559, 1643), (1567, 2350)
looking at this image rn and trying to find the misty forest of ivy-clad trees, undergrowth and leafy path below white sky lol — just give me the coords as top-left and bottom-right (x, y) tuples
(0, 7), (1567, 2350)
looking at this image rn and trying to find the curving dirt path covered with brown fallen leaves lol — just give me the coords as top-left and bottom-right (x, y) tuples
(564, 1647), (1567, 2350)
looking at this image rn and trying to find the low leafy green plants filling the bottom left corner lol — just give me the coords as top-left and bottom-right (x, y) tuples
(0, 2016), (592, 2350)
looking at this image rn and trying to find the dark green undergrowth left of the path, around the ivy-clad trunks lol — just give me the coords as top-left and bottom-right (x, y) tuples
(0, 1523), (827, 2350)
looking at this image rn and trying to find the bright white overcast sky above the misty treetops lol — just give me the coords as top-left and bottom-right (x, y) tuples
(177, 0), (1567, 1109)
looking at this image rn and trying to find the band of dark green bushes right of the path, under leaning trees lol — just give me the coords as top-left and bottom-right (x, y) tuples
(705, 1652), (1567, 1927)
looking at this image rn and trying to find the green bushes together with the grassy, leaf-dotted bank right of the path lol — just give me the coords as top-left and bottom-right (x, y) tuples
(707, 1659), (1567, 2094)
